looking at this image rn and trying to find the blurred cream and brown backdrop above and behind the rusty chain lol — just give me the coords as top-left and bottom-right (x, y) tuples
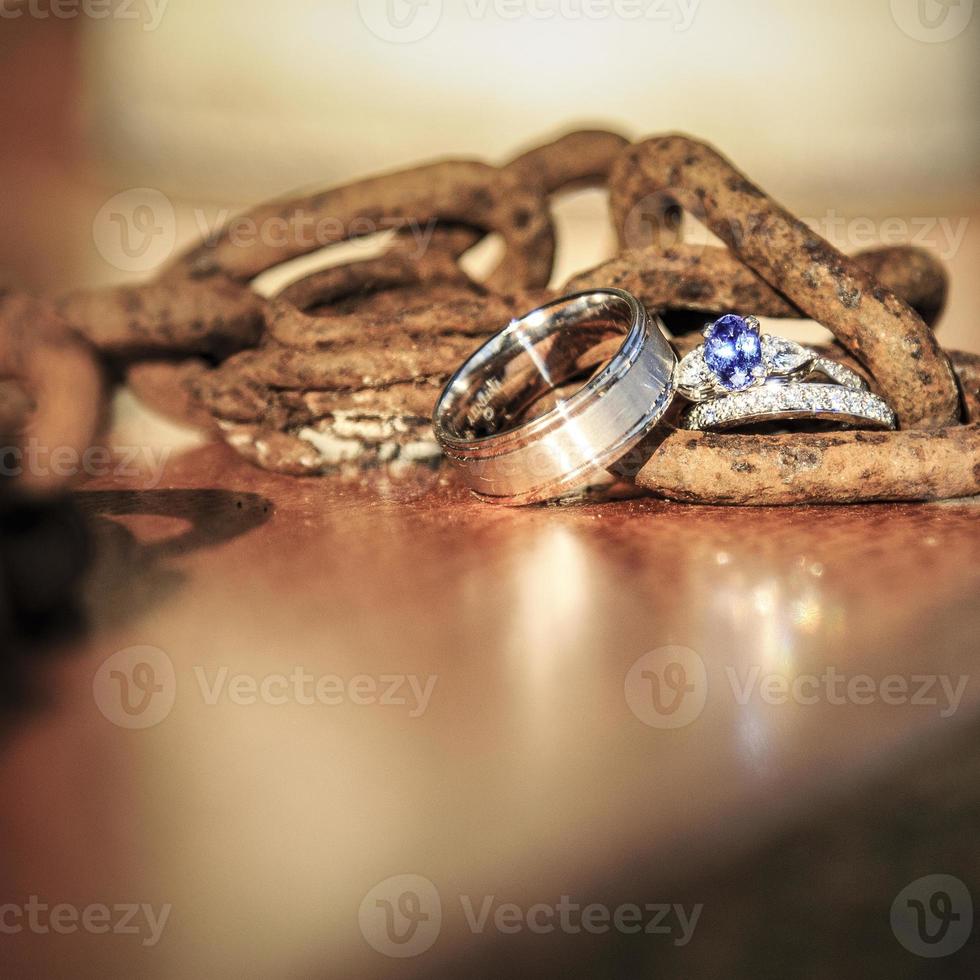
(0, 0), (980, 349)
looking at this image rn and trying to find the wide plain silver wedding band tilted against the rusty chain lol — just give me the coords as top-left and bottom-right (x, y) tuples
(433, 289), (677, 504)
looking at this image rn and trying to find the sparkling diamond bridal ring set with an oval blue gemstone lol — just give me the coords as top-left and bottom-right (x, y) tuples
(675, 313), (895, 429)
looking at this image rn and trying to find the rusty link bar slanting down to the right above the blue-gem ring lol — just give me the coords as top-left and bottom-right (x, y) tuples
(610, 136), (960, 429)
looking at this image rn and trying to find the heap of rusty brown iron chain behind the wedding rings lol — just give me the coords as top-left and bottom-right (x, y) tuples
(0, 131), (980, 504)
